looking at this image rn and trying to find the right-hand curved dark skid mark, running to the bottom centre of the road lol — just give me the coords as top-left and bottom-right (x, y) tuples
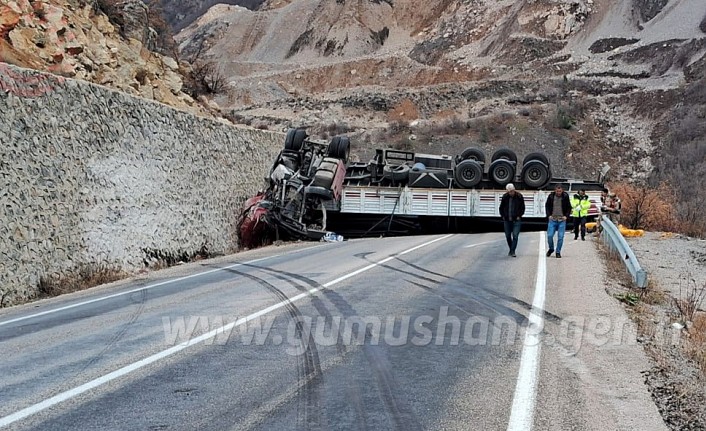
(239, 265), (421, 431)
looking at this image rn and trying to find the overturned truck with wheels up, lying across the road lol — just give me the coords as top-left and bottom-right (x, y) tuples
(238, 129), (606, 247)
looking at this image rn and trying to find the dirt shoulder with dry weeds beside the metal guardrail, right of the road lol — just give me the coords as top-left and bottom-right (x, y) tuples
(605, 232), (706, 430)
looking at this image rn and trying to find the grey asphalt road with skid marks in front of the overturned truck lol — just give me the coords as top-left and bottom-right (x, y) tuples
(0, 232), (661, 430)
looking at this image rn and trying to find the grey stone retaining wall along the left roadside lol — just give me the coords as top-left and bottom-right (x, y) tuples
(0, 64), (283, 306)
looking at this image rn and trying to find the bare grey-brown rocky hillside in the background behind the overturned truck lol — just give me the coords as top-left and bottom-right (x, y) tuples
(176, 0), (706, 235)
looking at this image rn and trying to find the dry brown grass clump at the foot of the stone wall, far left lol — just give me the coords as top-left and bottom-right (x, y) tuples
(38, 265), (127, 297)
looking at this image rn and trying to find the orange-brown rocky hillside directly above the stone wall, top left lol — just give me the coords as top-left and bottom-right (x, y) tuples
(0, 0), (216, 115)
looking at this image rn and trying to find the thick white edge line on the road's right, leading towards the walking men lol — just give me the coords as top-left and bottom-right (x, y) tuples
(507, 232), (547, 431)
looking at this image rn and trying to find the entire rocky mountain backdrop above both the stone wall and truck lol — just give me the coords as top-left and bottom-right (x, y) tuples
(5, 0), (706, 236)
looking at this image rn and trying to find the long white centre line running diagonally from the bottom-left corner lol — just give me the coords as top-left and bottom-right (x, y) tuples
(0, 235), (453, 427)
